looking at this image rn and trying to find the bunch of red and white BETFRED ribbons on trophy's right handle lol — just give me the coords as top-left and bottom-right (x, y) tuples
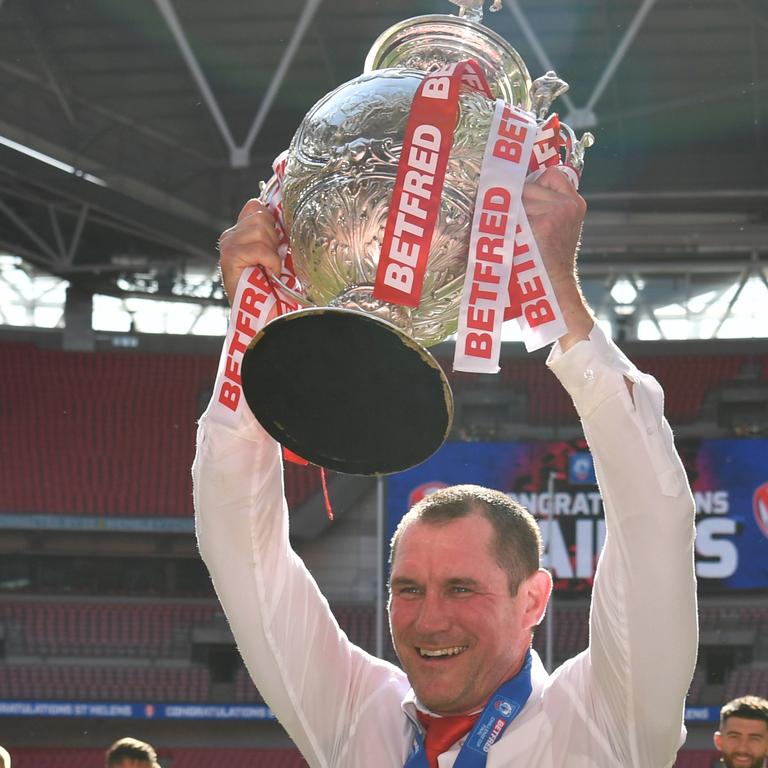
(453, 109), (567, 373)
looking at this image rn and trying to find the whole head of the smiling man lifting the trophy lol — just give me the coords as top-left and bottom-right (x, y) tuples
(389, 485), (552, 714)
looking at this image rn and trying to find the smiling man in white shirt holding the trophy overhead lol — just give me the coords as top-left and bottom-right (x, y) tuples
(193, 169), (697, 768)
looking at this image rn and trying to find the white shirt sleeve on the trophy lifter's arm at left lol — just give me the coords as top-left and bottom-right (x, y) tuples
(192, 372), (407, 766)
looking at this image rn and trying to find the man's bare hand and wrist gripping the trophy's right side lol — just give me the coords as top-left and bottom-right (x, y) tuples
(523, 168), (594, 351)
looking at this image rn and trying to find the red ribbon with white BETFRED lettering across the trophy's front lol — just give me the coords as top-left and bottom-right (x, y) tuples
(373, 59), (491, 307)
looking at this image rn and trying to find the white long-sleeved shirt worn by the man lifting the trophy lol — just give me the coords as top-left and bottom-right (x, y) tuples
(193, 326), (697, 768)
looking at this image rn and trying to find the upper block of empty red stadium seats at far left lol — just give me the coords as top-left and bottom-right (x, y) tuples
(0, 342), (320, 517)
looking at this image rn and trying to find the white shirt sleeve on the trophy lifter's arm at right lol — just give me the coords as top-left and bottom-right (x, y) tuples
(547, 326), (698, 768)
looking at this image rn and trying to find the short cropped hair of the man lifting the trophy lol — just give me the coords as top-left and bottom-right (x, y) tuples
(389, 485), (541, 595)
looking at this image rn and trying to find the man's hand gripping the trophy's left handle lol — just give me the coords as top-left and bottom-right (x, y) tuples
(219, 198), (281, 303)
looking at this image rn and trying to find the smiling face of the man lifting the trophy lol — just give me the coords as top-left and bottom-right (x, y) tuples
(389, 514), (549, 714)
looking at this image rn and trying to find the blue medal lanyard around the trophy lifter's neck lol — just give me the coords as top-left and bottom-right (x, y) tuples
(404, 651), (532, 768)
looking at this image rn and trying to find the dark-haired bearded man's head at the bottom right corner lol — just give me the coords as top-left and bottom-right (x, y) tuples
(715, 696), (768, 768)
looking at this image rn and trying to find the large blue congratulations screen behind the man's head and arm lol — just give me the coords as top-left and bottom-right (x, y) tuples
(386, 439), (768, 592)
